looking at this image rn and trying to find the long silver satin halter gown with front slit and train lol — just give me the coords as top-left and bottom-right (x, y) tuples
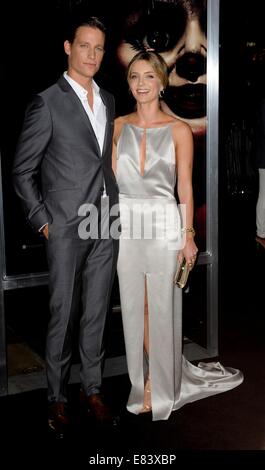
(117, 124), (243, 420)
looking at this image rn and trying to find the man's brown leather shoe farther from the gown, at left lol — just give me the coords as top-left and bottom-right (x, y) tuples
(48, 402), (69, 439)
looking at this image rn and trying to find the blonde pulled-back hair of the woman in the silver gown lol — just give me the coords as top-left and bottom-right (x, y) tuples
(127, 51), (168, 89)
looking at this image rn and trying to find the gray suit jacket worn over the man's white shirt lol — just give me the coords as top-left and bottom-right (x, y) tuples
(13, 76), (118, 238)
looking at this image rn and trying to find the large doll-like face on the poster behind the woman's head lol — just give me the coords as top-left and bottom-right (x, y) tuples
(117, 2), (207, 135)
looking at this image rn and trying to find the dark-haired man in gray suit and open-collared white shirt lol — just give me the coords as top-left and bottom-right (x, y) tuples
(13, 17), (118, 436)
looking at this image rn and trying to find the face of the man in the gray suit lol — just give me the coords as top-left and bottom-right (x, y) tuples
(64, 26), (105, 82)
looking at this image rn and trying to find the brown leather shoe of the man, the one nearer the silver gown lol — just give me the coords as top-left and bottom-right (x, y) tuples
(80, 391), (118, 426)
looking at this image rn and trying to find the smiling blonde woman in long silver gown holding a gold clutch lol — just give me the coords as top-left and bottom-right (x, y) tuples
(110, 51), (243, 420)
